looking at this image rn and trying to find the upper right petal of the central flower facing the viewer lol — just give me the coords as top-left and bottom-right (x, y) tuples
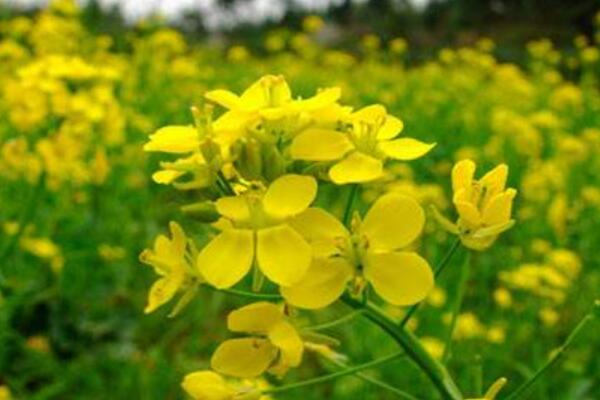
(263, 174), (317, 218)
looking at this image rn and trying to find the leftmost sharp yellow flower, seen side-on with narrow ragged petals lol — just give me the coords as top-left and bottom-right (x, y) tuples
(140, 222), (197, 314)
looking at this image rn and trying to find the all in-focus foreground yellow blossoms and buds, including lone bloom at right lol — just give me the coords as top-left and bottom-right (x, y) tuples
(140, 75), (515, 399)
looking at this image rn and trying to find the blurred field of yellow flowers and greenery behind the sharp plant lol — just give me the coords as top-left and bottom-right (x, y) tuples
(0, 0), (600, 400)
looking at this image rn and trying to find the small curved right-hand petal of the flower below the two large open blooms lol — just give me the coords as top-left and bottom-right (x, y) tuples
(268, 321), (304, 376)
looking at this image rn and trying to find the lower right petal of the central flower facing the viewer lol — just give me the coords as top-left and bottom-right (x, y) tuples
(256, 225), (312, 286)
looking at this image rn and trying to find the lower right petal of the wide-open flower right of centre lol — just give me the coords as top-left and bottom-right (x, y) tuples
(365, 251), (433, 306)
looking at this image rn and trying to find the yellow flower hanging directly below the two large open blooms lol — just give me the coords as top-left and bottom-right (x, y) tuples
(211, 302), (304, 378)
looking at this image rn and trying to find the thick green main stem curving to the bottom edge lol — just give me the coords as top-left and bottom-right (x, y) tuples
(342, 295), (463, 400)
